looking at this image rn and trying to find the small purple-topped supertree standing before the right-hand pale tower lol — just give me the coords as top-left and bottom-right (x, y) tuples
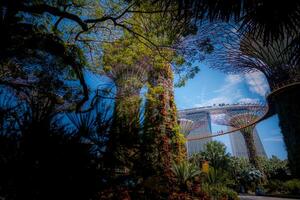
(215, 104), (266, 169)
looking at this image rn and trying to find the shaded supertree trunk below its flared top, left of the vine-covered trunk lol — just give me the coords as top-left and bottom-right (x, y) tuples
(105, 76), (142, 183)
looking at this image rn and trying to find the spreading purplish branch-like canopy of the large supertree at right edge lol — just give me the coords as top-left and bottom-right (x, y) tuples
(211, 27), (300, 90)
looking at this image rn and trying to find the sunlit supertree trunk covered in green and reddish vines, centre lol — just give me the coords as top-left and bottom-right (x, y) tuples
(142, 65), (185, 197)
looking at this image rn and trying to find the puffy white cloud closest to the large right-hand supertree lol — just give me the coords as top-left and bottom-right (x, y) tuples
(245, 71), (269, 97)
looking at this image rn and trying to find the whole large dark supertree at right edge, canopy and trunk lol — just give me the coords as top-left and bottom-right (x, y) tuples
(211, 27), (300, 177)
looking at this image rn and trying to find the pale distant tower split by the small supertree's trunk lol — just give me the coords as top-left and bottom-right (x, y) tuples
(229, 128), (267, 158)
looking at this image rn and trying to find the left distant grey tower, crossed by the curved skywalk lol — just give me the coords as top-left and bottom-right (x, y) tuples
(180, 111), (212, 156)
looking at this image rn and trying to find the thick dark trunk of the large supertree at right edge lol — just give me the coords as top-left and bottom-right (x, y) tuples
(271, 86), (300, 178)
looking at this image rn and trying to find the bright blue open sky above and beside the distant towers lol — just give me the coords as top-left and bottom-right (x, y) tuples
(174, 62), (287, 159)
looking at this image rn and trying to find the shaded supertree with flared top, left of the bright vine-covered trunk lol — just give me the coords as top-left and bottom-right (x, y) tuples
(105, 54), (149, 177)
